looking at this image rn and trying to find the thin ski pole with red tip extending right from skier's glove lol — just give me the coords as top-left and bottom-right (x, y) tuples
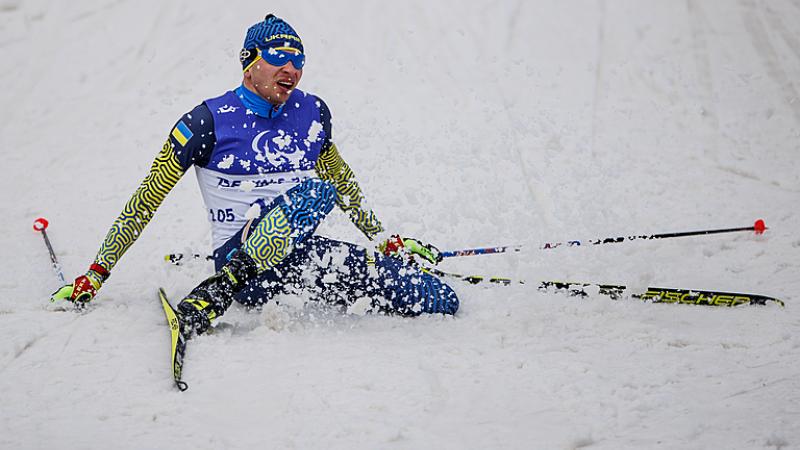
(442, 219), (768, 258)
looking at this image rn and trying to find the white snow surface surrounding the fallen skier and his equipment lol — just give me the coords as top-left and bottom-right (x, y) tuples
(0, 0), (800, 449)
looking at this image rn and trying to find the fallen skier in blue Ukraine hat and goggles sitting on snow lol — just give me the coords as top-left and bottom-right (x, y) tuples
(53, 14), (459, 339)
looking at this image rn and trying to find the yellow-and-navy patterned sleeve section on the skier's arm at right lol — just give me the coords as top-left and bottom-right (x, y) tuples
(314, 143), (383, 239)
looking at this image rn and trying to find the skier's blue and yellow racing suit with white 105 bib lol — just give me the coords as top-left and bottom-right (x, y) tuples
(90, 86), (459, 315)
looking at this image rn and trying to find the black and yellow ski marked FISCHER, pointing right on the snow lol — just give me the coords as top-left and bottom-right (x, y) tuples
(419, 266), (784, 307)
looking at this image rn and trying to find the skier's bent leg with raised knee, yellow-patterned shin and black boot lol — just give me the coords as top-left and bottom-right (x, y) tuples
(178, 179), (336, 334)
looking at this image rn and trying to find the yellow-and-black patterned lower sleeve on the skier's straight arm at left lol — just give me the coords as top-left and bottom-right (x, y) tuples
(95, 139), (185, 271)
